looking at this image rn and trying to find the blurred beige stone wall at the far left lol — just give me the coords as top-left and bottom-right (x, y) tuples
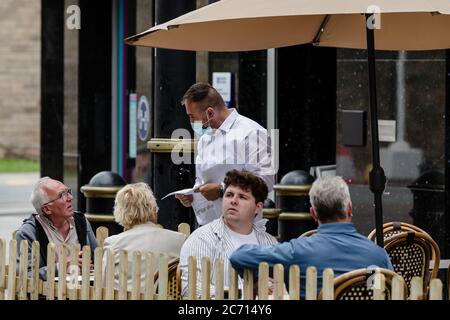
(0, 0), (41, 159)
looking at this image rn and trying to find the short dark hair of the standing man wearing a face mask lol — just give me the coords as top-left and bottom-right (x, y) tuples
(181, 82), (225, 110)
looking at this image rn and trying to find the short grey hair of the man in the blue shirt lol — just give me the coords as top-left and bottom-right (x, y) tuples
(309, 176), (351, 222)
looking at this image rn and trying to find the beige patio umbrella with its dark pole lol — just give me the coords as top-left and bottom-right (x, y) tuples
(125, 0), (450, 246)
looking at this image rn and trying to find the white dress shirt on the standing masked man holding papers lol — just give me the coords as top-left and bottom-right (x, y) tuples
(192, 109), (275, 225)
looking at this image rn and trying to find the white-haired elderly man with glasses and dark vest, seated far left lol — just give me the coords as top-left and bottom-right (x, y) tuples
(16, 177), (97, 280)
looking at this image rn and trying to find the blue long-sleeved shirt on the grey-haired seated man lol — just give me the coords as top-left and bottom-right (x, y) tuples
(230, 222), (393, 298)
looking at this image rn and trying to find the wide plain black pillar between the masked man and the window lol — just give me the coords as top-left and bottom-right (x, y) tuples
(277, 45), (336, 179)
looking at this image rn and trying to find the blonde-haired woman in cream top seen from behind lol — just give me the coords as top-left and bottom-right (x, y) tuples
(103, 182), (186, 290)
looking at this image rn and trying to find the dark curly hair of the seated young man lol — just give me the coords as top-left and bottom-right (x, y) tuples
(224, 170), (269, 203)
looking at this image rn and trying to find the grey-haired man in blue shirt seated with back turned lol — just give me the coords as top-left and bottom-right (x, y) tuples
(230, 177), (392, 297)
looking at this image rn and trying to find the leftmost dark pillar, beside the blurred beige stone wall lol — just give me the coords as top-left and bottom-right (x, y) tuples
(40, 0), (65, 180)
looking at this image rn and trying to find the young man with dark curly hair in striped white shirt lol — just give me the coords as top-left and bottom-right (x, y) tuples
(180, 170), (277, 296)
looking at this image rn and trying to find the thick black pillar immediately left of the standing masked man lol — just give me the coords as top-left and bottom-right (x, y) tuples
(153, 0), (196, 230)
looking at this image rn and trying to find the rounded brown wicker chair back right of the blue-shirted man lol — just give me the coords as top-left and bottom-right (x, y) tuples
(384, 231), (440, 292)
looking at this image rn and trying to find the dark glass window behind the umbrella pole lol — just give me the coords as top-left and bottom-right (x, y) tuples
(336, 49), (446, 240)
